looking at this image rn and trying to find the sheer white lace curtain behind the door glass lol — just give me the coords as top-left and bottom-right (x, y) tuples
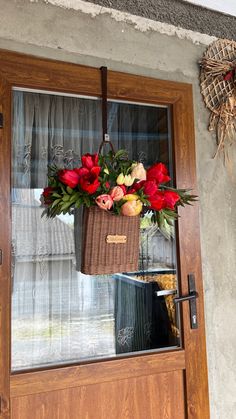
(12, 91), (170, 369)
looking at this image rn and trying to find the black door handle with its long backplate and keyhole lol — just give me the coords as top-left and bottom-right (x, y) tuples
(174, 274), (198, 329)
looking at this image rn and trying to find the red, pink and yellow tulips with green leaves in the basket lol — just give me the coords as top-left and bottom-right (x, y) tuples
(41, 150), (196, 235)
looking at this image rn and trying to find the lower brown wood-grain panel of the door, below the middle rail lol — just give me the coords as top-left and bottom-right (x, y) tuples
(12, 371), (185, 419)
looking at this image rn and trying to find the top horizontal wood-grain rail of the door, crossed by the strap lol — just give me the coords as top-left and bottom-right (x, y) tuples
(0, 50), (189, 105)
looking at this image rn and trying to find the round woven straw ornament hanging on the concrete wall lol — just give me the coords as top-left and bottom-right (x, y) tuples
(200, 39), (236, 157)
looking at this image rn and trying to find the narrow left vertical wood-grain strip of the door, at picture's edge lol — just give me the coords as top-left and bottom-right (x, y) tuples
(0, 77), (11, 419)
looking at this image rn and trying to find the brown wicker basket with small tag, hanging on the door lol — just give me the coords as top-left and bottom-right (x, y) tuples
(81, 207), (140, 275)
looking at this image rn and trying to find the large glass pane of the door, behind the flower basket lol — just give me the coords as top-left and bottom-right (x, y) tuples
(12, 89), (180, 371)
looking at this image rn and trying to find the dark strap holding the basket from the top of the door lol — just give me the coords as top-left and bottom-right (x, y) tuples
(98, 67), (115, 154)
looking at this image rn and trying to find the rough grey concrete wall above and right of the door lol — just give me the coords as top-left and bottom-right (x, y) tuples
(0, 0), (236, 419)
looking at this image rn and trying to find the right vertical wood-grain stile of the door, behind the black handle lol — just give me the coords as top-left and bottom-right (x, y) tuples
(173, 86), (209, 419)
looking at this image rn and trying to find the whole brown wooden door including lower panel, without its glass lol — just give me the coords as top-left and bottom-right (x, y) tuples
(0, 51), (209, 419)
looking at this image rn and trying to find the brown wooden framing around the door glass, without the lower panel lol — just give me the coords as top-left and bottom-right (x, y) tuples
(0, 50), (209, 419)
